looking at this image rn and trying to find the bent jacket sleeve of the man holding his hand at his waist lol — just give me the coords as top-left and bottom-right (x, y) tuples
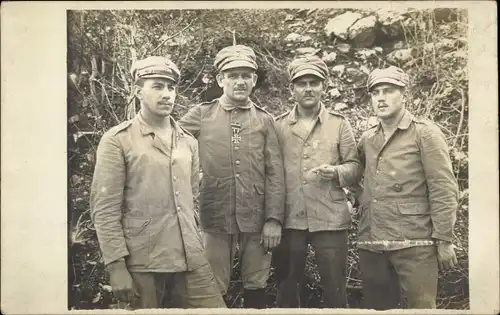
(337, 119), (362, 187)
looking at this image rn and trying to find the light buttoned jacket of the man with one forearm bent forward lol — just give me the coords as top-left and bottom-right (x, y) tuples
(276, 104), (362, 232)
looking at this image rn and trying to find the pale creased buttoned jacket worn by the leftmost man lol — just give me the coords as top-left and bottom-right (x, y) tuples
(90, 114), (207, 272)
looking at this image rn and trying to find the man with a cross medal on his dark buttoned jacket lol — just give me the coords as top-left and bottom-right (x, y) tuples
(180, 45), (284, 308)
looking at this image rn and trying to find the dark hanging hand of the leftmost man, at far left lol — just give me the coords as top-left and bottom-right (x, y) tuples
(108, 259), (139, 303)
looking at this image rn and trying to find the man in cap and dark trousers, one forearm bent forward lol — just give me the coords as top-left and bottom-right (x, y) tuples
(273, 56), (361, 308)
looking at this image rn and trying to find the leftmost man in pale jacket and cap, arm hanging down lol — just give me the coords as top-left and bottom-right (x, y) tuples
(90, 56), (226, 308)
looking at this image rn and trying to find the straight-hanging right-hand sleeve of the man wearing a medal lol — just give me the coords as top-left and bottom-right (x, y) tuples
(264, 117), (285, 225)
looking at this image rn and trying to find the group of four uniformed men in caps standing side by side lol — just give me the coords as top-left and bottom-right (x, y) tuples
(91, 45), (458, 309)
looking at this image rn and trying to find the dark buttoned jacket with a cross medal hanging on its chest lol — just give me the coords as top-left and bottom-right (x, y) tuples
(179, 97), (285, 233)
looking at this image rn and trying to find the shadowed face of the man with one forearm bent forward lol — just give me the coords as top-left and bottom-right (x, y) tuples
(290, 74), (324, 109)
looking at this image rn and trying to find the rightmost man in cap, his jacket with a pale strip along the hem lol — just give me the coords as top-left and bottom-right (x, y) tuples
(358, 66), (458, 310)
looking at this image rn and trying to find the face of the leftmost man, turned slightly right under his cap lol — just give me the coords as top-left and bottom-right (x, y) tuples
(136, 78), (177, 117)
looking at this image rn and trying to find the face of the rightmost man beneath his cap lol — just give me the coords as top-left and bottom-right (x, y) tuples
(370, 83), (404, 119)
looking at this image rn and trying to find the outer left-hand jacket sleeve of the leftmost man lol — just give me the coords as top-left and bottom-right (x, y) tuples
(90, 134), (129, 265)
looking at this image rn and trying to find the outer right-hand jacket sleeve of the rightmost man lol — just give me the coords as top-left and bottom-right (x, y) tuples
(421, 125), (458, 241)
